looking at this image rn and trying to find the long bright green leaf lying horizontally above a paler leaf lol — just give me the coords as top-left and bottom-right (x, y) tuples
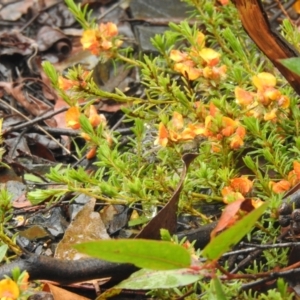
(74, 239), (191, 270)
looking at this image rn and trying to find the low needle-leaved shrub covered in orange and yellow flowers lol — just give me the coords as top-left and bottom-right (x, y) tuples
(36, 0), (300, 299)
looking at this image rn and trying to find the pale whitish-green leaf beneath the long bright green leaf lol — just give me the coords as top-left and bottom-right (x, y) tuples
(114, 269), (200, 290)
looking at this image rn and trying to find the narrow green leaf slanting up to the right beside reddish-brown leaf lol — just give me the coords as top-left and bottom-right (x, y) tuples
(201, 203), (268, 260)
